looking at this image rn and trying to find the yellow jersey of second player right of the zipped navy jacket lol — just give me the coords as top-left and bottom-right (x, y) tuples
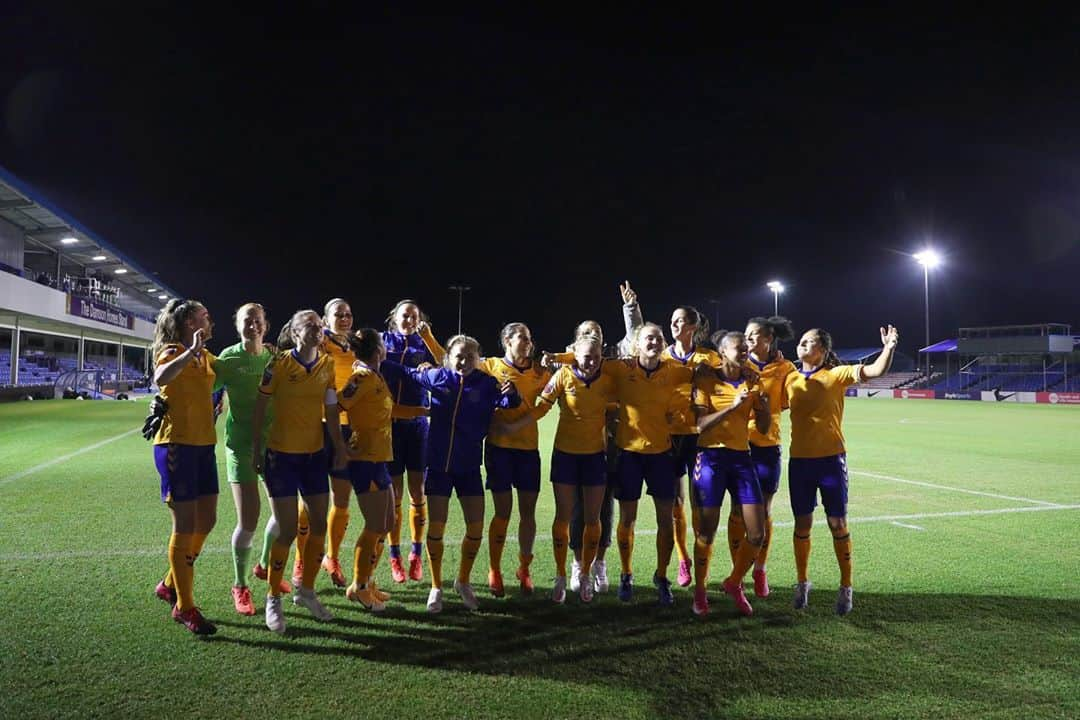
(532, 365), (616, 454)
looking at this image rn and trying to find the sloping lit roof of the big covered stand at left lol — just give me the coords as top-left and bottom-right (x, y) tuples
(0, 167), (179, 318)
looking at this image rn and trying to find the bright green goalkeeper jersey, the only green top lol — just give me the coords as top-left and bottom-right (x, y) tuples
(214, 342), (274, 452)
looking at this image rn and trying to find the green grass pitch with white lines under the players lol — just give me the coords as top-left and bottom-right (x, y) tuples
(0, 400), (1080, 720)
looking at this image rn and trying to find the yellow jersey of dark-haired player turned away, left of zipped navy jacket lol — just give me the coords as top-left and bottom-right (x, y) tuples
(338, 365), (394, 462)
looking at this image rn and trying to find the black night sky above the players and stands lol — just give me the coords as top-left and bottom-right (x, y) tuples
(0, 6), (1080, 353)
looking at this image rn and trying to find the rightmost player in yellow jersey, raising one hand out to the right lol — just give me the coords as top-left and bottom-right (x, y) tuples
(784, 325), (900, 615)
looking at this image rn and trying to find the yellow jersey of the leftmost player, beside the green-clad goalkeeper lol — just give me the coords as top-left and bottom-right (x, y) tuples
(153, 344), (217, 445)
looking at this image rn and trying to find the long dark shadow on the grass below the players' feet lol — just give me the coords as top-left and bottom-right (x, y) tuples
(203, 587), (1080, 716)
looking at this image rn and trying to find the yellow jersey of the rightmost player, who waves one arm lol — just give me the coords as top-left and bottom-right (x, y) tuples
(784, 365), (863, 458)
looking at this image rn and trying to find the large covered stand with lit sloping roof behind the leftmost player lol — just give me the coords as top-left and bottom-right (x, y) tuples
(0, 167), (177, 399)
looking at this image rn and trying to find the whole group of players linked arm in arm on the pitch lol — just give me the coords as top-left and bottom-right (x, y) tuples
(147, 283), (897, 635)
